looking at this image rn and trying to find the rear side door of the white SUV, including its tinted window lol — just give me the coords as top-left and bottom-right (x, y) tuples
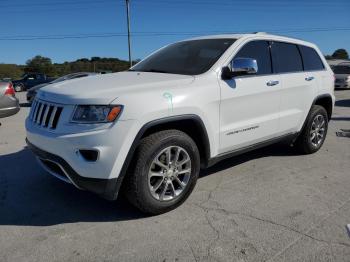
(271, 42), (317, 134)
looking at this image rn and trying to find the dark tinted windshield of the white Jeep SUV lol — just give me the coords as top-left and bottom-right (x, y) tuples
(130, 38), (236, 75)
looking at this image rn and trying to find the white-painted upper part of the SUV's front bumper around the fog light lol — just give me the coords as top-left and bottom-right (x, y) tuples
(26, 115), (133, 179)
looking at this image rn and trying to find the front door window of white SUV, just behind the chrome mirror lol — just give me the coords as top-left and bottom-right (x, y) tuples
(235, 41), (272, 75)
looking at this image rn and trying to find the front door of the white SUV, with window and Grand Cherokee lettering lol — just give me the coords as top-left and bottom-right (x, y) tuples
(219, 40), (281, 153)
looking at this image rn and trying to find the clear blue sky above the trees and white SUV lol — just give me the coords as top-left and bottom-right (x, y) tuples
(0, 0), (350, 64)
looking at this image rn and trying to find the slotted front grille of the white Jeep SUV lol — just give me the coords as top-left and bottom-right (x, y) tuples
(29, 100), (63, 129)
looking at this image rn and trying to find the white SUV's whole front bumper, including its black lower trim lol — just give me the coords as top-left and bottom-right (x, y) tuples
(26, 99), (137, 199)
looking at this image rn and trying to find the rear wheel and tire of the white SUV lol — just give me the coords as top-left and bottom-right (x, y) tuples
(295, 105), (328, 154)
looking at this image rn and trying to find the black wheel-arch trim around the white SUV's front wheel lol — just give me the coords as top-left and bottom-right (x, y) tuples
(108, 114), (210, 200)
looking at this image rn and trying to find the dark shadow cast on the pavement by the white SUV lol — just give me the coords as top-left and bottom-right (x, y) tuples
(0, 142), (295, 226)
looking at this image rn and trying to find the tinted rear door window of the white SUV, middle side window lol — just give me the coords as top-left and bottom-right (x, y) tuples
(271, 42), (303, 73)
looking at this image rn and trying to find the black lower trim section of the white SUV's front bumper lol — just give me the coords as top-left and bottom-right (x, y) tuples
(26, 139), (120, 200)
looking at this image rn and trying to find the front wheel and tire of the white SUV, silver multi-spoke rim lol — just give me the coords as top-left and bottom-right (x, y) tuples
(125, 130), (200, 215)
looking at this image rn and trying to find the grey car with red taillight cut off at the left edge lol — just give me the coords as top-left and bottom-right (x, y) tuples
(0, 81), (20, 118)
